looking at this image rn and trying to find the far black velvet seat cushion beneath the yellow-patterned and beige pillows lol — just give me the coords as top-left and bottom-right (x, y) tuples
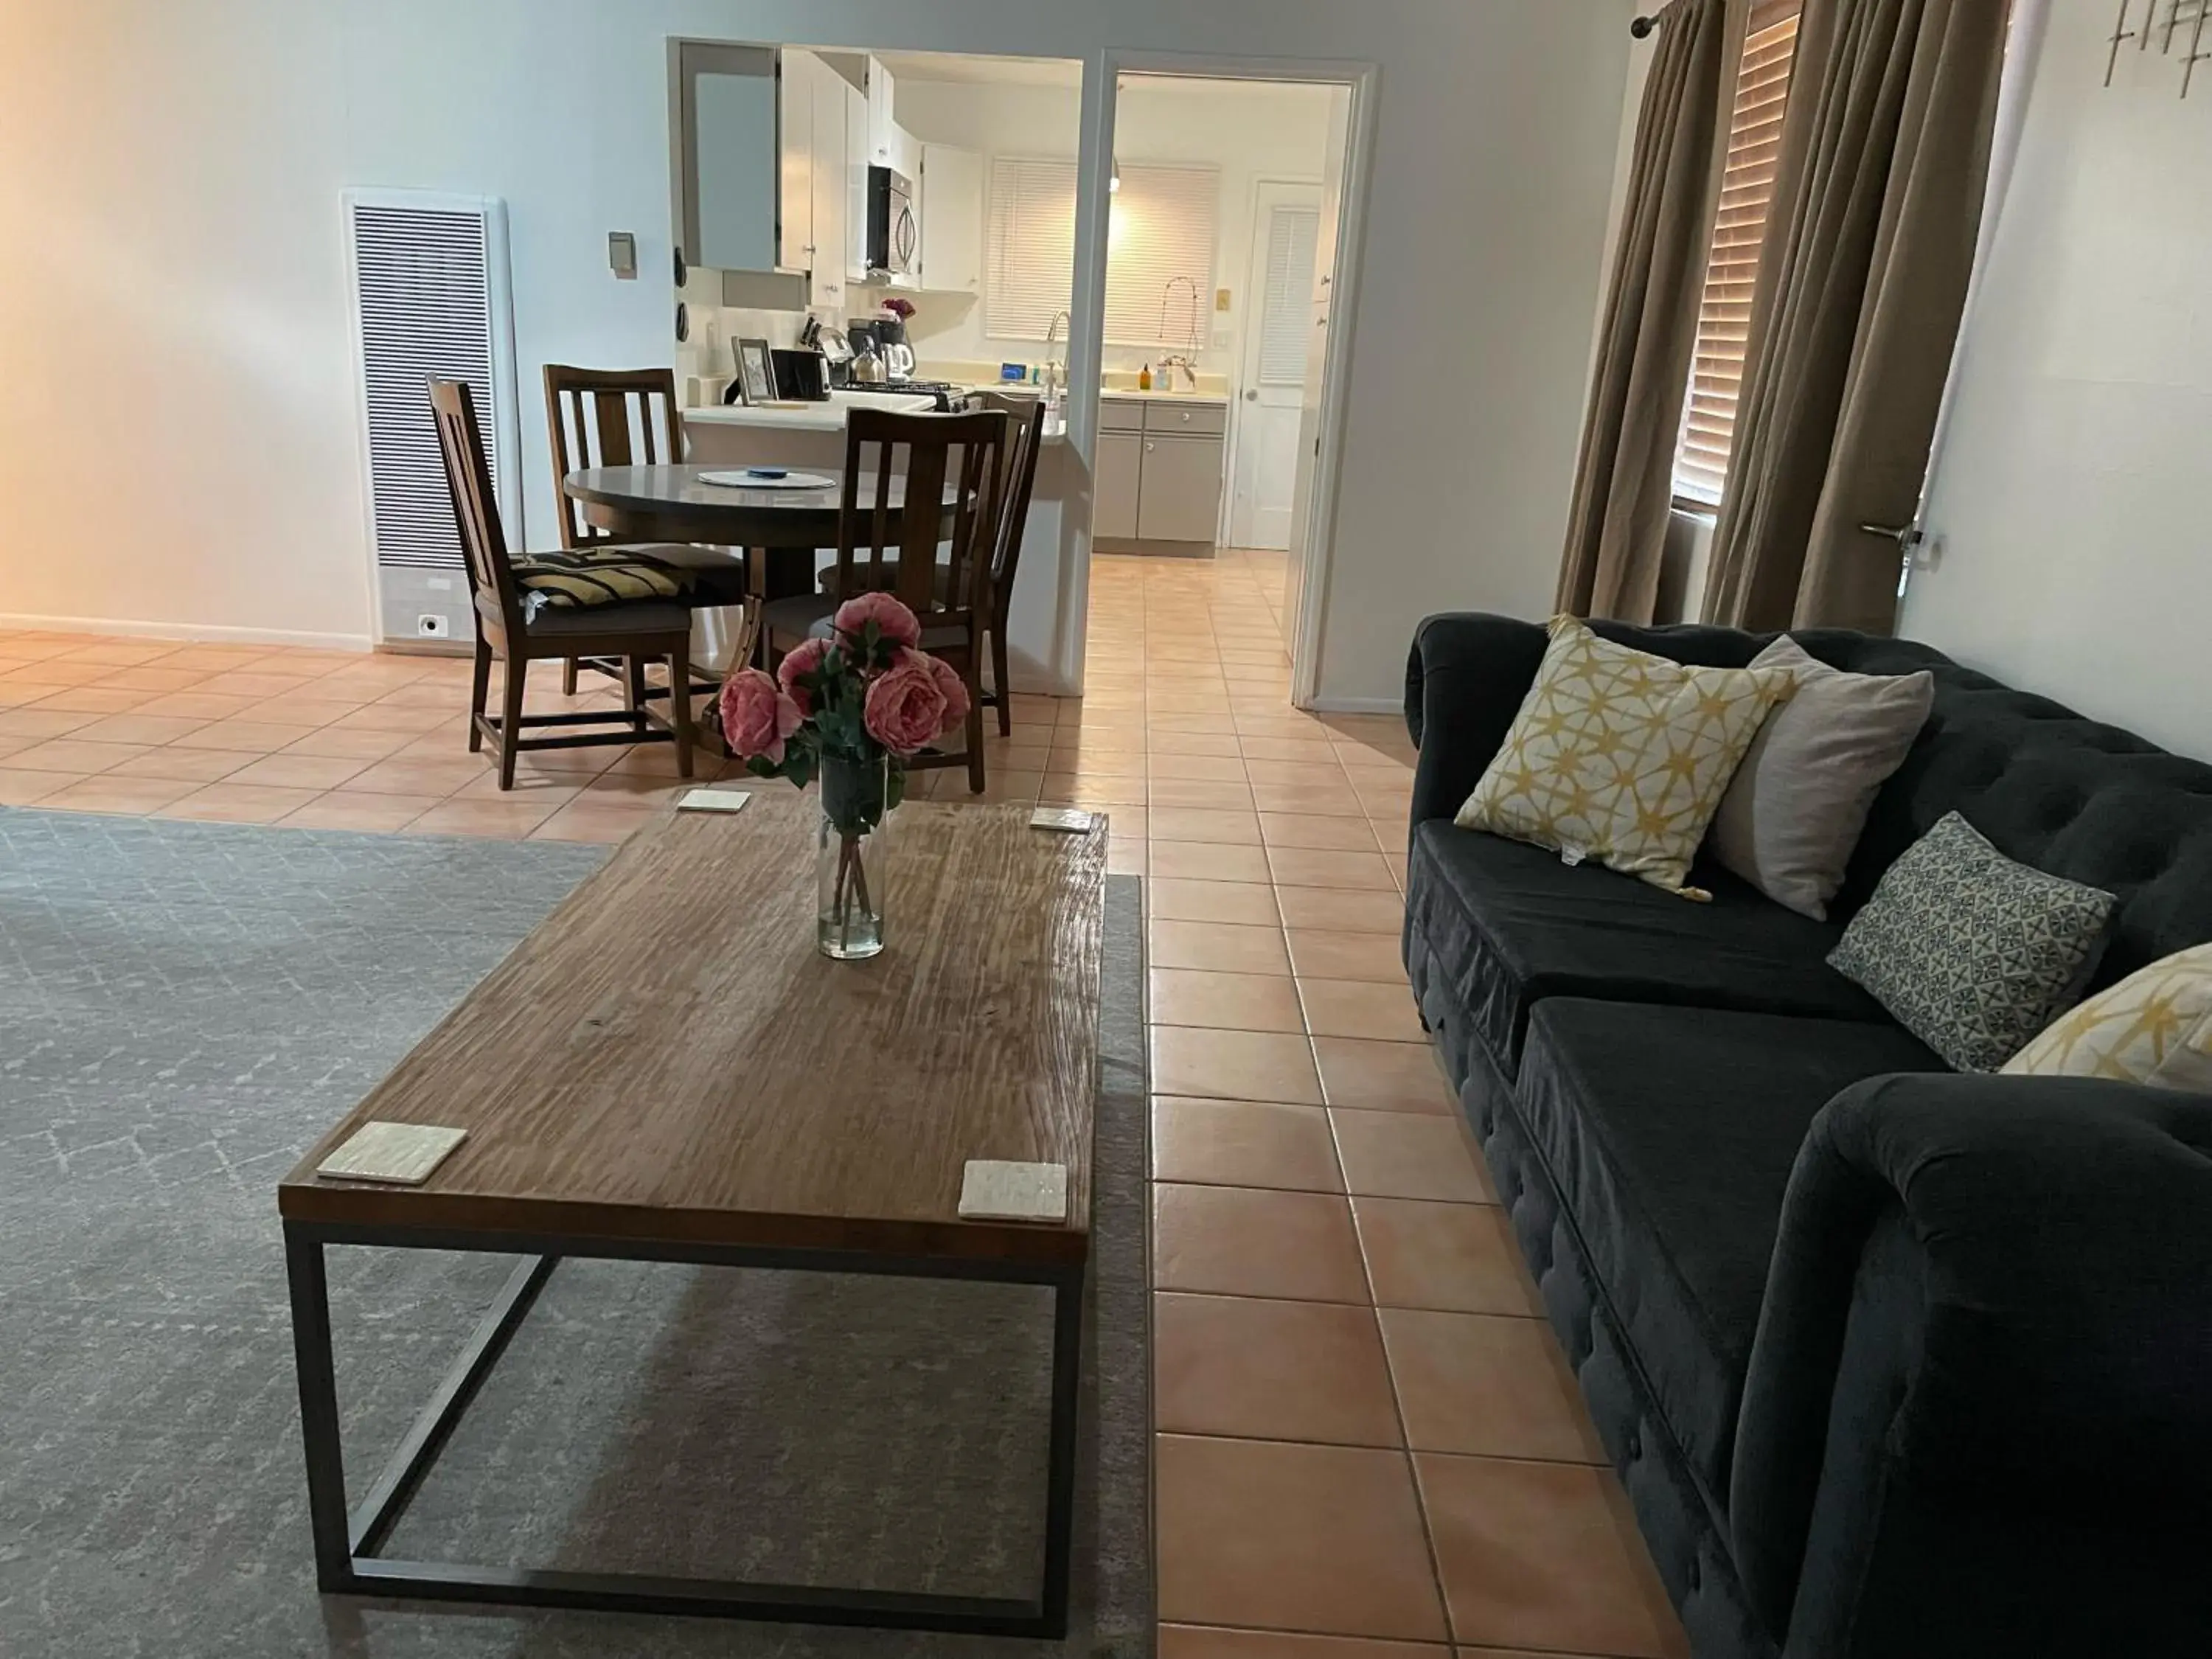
(1407, 818), (1887, 1077)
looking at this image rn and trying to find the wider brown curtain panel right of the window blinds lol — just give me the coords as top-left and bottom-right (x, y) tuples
(1703, 0), (2006, 633)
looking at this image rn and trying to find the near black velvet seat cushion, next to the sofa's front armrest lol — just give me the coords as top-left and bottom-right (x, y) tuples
(1513, 998), (1944, 1513)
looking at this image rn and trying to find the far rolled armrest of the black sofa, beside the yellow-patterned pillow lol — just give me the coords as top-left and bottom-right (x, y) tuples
(1405, 611), (1546, 825)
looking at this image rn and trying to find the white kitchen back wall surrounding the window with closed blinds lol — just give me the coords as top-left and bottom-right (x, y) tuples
(896, 77), (1332, 380)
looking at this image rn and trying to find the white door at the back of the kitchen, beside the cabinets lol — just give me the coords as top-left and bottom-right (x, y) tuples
(1230, 179), (1321, 549)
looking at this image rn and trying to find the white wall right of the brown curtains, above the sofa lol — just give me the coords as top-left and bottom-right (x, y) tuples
(1900, 0), (2212, 759)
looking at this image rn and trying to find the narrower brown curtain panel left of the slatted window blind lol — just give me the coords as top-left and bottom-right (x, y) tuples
(1557, 0), (1745, 622)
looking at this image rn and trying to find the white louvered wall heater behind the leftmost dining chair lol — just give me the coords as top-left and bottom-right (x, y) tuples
(345, 190), (522, 571)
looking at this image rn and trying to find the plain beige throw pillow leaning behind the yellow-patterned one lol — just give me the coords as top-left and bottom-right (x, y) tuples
(1712, 635), (1935, 920)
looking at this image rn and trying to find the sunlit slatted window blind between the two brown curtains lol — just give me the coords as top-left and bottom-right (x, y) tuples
(1674, 7), (1798, 507)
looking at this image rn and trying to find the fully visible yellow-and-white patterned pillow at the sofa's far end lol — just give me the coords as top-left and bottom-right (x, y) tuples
(1455, 617), (1796, 898)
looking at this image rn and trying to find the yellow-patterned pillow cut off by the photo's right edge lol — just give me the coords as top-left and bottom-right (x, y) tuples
(2004, 945), (2212, 1095)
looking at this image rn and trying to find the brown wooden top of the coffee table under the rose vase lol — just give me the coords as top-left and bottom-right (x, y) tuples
(279, 796), (1106, 1265)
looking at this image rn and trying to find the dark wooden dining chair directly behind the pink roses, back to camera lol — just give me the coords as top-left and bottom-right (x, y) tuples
(761, 409), (1006, 794)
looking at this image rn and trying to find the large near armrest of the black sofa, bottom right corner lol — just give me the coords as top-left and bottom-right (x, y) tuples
(1730, 1075), (2212, 1657)
